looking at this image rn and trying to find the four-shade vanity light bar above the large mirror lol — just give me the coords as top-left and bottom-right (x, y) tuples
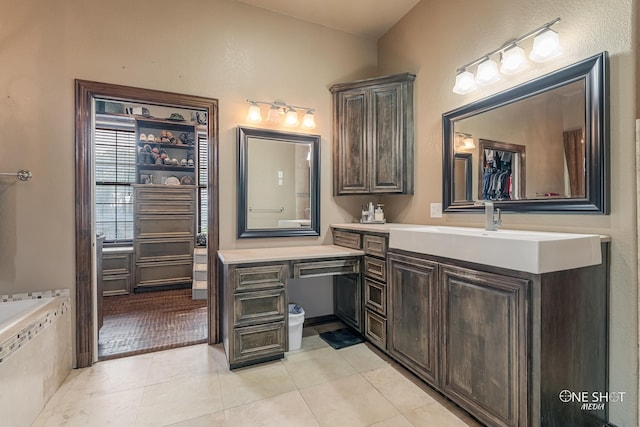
(453, 18), (563, 95)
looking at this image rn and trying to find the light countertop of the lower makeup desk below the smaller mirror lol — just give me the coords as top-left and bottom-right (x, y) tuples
(218, 245), (364, 264)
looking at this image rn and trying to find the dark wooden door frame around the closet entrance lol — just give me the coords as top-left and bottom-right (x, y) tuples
(75, 79), (220, 368)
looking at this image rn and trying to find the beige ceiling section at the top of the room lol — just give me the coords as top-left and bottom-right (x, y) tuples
(236, 0), (420, 39)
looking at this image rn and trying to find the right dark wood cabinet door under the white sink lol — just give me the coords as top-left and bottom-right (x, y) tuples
(440, 265), (528, 426)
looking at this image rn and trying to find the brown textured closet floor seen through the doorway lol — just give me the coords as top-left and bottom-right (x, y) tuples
(98, 289), (207, 360)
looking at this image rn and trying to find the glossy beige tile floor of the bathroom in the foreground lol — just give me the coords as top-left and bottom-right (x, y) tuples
(33, 330), (478, 427)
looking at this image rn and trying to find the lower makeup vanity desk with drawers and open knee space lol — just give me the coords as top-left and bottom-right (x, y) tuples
(218, 245), (363, 369)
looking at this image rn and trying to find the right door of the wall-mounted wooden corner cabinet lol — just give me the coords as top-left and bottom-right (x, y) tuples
(368, 83), (404, 193)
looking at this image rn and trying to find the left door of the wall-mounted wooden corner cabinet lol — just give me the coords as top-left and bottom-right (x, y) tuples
(334, 89), (368, 194)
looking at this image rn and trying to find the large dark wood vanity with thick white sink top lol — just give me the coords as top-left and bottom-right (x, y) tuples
(333, 224), (609, 426)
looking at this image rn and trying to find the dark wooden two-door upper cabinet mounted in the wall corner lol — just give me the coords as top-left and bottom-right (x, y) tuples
(331, 73), (415, 196)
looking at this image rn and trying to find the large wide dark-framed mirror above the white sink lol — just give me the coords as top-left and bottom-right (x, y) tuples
(442, 52), (609, 214)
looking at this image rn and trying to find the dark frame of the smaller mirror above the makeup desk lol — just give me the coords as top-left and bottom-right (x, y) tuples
(238, 126), (320, 239)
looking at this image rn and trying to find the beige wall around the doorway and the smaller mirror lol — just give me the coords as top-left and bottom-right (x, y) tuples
(0, 0), (377, 294)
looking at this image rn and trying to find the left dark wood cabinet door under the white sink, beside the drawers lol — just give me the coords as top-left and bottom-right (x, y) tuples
(387, 253), (439, 386)
